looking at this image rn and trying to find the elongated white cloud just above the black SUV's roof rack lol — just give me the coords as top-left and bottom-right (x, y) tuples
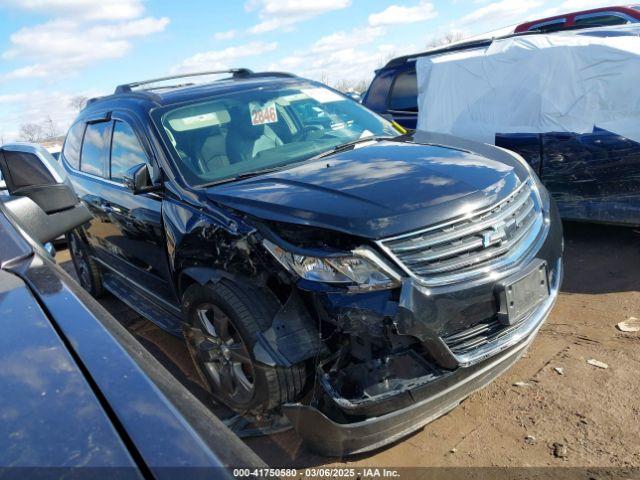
(172, 42), (278, 72)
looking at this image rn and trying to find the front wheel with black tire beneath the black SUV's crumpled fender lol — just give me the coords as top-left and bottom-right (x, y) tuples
(182, 281), (306, 414)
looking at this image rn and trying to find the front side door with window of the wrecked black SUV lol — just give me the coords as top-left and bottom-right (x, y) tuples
(102, 113), (176, 304)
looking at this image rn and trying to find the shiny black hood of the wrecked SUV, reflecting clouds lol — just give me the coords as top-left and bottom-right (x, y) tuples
(207, 141), (522, 239)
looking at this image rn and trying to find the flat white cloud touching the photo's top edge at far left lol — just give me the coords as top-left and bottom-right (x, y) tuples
(0, 0), (144, 20)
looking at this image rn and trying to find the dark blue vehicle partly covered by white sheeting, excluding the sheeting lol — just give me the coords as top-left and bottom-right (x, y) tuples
(362, 31), (640, 225)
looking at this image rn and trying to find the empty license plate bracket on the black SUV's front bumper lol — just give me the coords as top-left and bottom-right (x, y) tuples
(498, 260), (549, 325)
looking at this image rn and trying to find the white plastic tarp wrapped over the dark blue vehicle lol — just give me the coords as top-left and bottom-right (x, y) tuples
(416, 25), (640, 143)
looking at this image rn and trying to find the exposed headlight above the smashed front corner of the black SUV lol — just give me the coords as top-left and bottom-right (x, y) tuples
(263, 240), (400, 291)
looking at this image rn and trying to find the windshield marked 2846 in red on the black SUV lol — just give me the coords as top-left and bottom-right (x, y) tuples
(154, 84), (398, 186)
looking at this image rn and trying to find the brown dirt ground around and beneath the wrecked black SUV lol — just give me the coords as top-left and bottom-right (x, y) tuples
(58, 223), (640, 468)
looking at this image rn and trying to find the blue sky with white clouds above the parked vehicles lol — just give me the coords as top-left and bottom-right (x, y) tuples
(0, 0), (615, 141)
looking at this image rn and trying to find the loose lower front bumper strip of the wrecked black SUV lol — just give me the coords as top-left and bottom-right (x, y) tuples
(283, 260), (562, 457)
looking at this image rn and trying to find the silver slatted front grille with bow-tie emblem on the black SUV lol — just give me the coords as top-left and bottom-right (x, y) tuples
(379, 182), (543, 285)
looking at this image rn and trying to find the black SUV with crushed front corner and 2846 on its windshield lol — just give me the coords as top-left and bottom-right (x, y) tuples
(62, 69), (562, 455)
